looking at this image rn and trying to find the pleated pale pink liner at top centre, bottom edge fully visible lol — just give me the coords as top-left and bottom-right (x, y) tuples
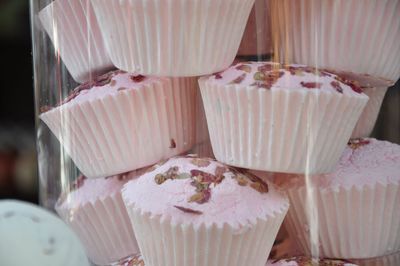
(92, 0), (254, 77)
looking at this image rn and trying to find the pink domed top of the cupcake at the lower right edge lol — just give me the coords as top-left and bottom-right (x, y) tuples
(282, 139), (400, 189)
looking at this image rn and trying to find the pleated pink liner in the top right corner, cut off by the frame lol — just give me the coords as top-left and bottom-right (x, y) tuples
(270, 0), (400, 81)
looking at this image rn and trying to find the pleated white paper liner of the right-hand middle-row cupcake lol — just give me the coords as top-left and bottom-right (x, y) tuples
(199, 79), (368, 174)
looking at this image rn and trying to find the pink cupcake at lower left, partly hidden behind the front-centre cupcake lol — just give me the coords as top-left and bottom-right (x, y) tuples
(55, 169), (145, 265)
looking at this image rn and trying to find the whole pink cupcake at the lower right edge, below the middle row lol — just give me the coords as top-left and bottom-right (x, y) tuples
(285, 139), (400, 259)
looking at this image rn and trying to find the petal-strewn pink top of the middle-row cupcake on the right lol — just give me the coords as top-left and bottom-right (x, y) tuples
(207, 62), (365, 97)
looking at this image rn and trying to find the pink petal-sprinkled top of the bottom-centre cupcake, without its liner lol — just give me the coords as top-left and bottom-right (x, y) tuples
(122, 157), (289, 229)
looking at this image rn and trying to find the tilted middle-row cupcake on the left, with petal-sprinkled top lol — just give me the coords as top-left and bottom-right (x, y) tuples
(40, 71), (197, 178)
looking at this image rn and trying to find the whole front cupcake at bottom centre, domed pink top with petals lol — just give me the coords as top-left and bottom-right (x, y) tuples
(122, 156), (289, 266)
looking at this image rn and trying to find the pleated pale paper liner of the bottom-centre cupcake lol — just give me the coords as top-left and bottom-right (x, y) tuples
(125, 200), (287, 266)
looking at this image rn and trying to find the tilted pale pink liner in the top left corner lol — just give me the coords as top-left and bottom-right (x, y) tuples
(38, 0), (114, 83)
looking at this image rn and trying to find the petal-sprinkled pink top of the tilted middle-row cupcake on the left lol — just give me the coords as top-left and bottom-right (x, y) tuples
(44, 70), (162, 109)
